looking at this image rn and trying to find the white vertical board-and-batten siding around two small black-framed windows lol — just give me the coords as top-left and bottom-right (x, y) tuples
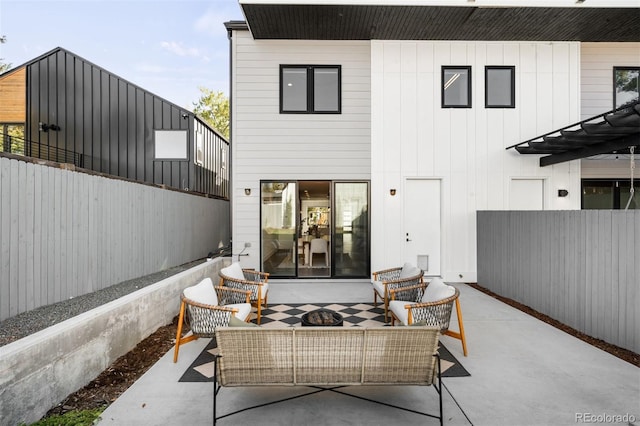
(371, 41), (580, 281)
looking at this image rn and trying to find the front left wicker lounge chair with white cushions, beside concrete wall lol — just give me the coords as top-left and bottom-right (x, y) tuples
(173, 278), (251, 362)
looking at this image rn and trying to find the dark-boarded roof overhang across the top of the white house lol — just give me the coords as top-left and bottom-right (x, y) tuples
(240, 0), (640, 42)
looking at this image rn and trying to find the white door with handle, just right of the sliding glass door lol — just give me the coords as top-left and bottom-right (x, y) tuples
(403, 179), (441, 276)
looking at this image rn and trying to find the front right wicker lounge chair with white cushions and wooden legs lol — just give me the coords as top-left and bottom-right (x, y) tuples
(389, 278), (467, 356)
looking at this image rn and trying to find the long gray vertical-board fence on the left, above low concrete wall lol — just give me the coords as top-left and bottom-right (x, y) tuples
(0, 157), (230, 321)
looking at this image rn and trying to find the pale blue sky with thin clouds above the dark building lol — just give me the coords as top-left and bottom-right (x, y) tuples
(0, 0), (244, 111)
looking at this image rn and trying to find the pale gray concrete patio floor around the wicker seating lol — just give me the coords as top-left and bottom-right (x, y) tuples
(99, 280), (640, 426)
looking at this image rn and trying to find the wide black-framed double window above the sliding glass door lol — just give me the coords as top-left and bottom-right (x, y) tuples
(280, 65), (342, 114)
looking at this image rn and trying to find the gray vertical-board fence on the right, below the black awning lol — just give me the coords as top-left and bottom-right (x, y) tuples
(477, 210), (640, 352)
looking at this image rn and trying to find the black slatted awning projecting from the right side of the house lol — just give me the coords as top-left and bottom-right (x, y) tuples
(507, 101), (640, 167)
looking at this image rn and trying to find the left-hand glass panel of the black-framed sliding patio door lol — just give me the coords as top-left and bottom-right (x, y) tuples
(260, 182), (298, 277)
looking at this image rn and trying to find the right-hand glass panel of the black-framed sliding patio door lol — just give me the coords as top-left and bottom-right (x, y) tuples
(332, 182), (370, 277)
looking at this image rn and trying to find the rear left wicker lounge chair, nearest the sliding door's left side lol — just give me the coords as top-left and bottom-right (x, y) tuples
(218, 262), (269, 324)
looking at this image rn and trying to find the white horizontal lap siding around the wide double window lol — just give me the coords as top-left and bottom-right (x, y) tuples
(231, 31), (371, 262)
